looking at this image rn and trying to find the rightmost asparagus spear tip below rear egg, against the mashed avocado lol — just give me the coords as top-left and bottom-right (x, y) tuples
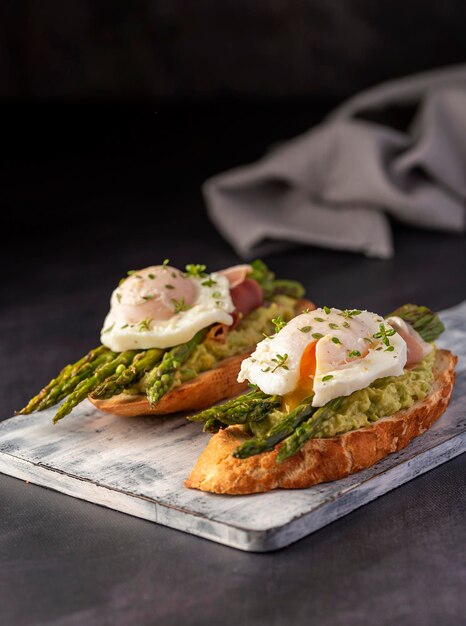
(146, 328), (209, 407)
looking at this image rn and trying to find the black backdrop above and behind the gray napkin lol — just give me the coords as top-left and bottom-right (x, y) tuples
(0, 0), (466, 241)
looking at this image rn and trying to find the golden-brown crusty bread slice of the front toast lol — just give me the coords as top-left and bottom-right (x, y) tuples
(185, 350), (457, 494)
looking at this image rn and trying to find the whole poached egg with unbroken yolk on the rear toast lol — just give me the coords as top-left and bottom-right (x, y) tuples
(100, 264), (235, 352)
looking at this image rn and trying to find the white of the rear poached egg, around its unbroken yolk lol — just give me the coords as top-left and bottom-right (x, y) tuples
(100, 272), (235, 352)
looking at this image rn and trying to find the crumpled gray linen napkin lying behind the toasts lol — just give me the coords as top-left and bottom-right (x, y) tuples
(203, 65), (466, 259)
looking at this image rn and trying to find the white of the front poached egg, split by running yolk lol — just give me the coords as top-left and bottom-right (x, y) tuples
(238, 309), (407, 407)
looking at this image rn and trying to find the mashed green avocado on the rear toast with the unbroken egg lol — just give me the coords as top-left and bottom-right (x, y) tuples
(137, 295), (296, 393)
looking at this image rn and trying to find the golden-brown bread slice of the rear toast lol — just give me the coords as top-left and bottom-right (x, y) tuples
(89, 298), (315, 417)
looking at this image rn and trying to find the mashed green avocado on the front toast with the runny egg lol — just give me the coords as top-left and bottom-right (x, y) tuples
(249, 348), (435, 438)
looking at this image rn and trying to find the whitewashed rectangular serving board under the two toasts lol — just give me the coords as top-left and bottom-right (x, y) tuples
(0, 301), (466, 552)
